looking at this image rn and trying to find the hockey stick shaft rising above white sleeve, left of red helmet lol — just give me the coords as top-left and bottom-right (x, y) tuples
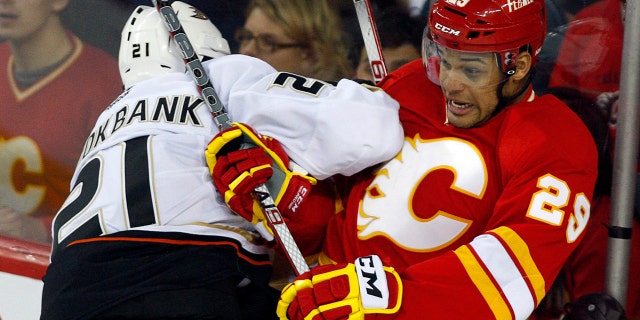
(353, 0), (387, 83)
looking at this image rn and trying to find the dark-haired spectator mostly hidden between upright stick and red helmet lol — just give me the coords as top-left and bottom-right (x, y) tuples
(355, 6), (426, 81)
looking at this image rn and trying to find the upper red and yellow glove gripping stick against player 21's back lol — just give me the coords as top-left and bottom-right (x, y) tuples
(205, 123), (316, 241)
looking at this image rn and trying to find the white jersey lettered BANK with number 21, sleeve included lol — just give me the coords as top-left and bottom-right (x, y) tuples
(53, 55), (404, 253)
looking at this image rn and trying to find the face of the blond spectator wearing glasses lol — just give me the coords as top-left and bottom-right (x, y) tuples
(240, 8), (312, 76)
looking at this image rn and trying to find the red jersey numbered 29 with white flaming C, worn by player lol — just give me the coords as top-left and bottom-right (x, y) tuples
(302, 60), (597, 319)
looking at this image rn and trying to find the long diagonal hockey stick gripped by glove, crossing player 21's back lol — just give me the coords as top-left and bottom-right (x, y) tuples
(152, 0), (309, 275)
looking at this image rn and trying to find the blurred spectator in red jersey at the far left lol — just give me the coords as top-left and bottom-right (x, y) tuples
(0, 0), (122, 241)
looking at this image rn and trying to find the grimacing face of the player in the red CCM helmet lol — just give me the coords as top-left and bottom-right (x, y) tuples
(439, 49), (504, 128)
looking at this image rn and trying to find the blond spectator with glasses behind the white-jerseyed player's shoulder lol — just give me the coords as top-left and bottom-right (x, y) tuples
(235, 0), (353, 80)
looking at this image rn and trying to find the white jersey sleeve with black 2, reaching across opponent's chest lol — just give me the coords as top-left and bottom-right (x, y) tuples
(207, 55), (404, 179)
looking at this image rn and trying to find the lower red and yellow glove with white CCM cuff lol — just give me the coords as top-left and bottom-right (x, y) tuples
(276, 255), (402, 320)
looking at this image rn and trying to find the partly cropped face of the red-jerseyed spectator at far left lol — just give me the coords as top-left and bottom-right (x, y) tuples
(0, 0), (68, 41)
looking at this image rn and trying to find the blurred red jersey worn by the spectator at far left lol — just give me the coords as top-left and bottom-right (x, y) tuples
(0, 36), (122, 222)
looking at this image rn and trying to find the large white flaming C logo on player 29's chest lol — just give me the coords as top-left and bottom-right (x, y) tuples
(358, 137), (487, 252)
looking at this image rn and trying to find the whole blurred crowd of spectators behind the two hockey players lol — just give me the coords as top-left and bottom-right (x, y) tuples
(0, 0), (640, 319)
